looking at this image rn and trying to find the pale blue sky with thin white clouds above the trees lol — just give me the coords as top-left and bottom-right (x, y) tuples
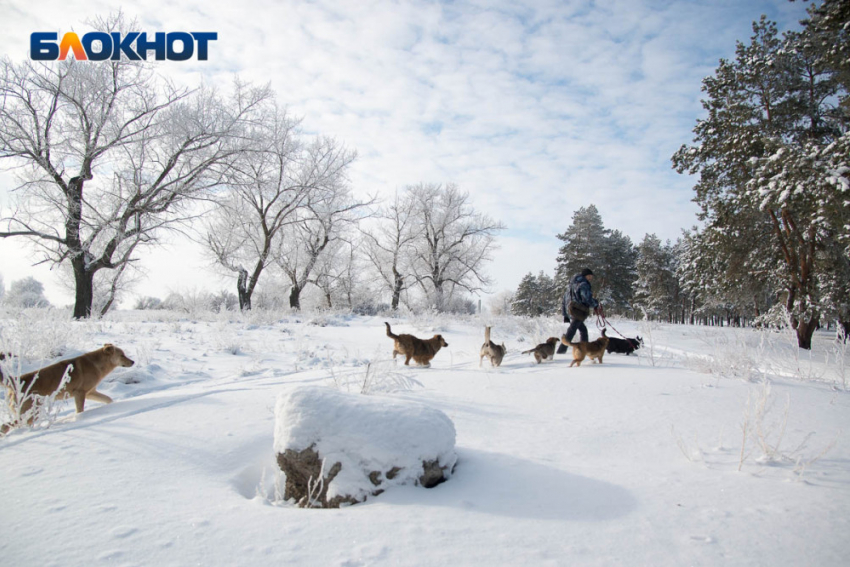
(0, 0), (808, 303)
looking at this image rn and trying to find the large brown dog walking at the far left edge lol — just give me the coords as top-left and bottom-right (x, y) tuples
(5, 344), (135, 421)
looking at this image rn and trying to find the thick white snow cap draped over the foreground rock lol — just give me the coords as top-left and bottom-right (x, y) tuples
(274, 386), (457, 501)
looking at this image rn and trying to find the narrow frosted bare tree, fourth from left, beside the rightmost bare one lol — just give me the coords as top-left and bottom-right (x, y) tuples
(363, 191), (423, 311)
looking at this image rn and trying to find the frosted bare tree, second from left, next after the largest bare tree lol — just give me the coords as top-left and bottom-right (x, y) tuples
(207, 103), (356, 310)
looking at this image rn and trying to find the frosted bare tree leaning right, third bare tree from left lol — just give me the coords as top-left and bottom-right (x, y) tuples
(275, 162), (373, 309)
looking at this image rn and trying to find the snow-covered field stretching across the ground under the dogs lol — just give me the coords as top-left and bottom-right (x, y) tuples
(0, 311), (850, 567)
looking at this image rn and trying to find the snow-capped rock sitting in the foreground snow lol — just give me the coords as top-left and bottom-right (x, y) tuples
(274, 386), (457, 508)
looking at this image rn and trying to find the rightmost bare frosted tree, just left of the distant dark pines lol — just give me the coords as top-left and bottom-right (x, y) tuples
(407, 183), (505, 311)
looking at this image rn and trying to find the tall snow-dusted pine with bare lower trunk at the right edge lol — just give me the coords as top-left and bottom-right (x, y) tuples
(672, 6), (850, 349)
